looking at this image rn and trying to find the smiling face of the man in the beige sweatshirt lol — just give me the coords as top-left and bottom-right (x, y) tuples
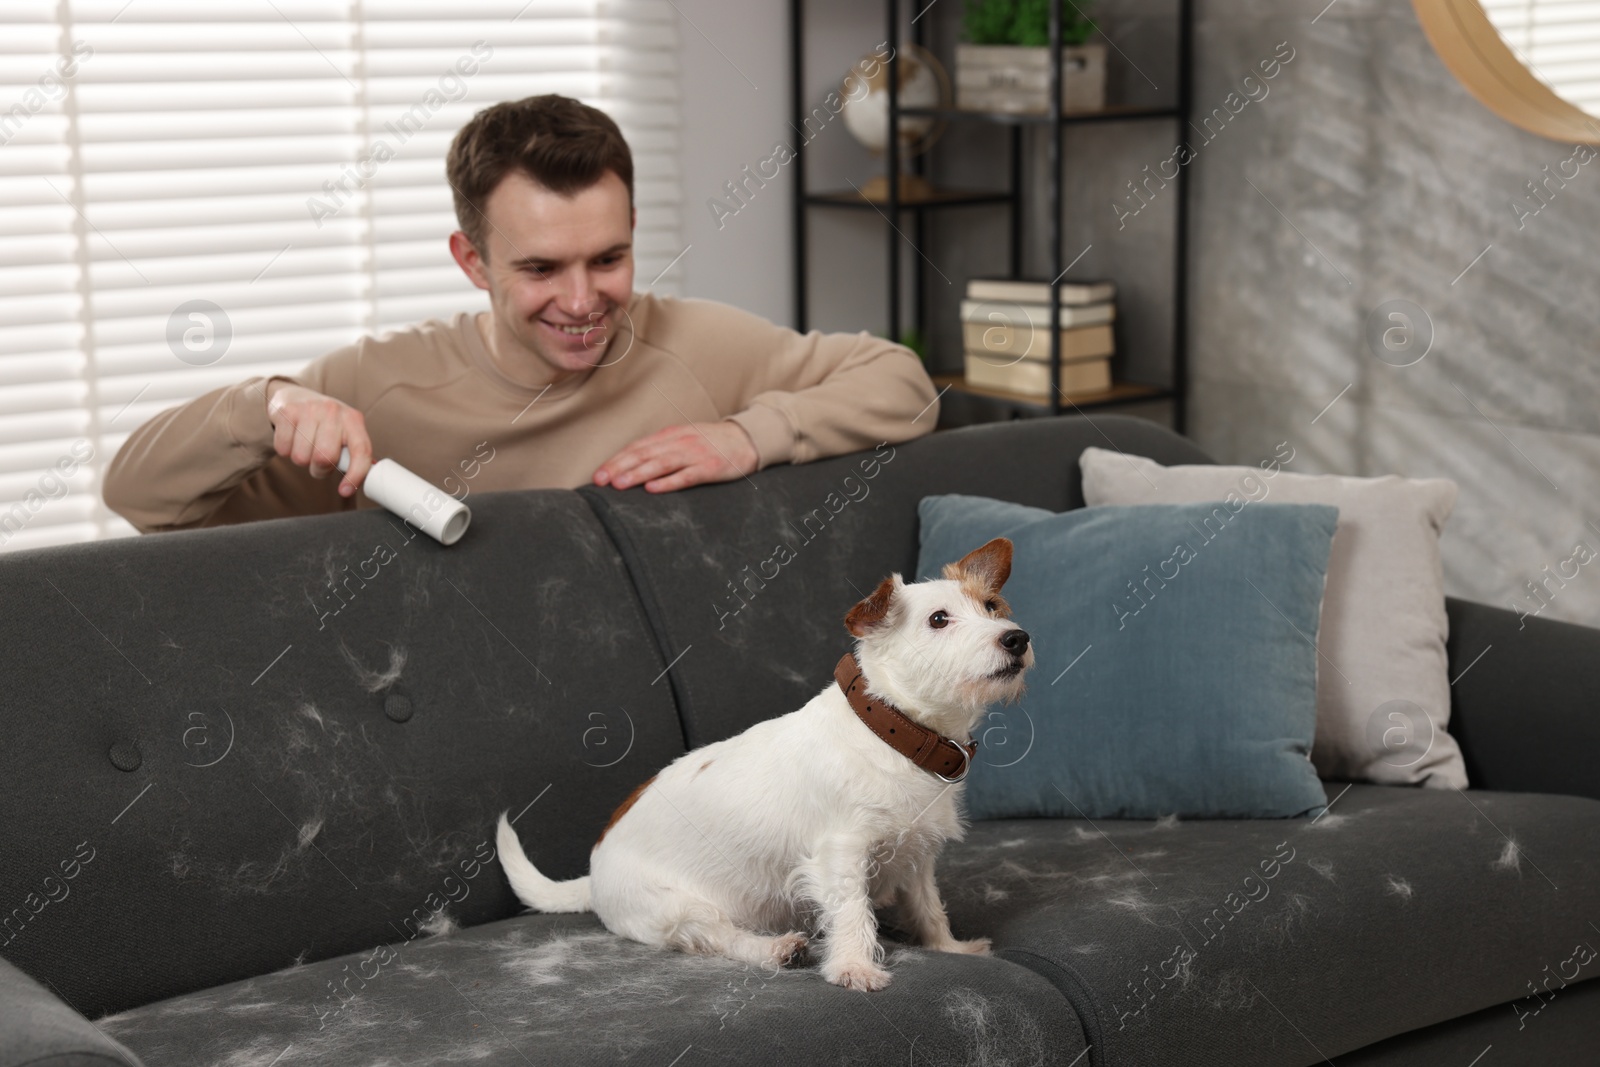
(450, 171), (634, 373)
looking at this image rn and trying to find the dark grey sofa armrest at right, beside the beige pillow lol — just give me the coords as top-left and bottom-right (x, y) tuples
(1445, 598), (1600, 798)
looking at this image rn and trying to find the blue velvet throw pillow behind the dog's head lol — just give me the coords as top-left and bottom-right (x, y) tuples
(917, 496), (1339, 819)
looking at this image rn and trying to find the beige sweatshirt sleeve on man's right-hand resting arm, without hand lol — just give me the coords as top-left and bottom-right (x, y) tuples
(682, 301), (939, 469)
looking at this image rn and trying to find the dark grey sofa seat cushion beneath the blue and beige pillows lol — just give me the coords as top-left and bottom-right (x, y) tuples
(938, 785), (1600, 1067)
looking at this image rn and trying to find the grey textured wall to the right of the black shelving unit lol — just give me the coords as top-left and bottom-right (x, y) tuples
(1190, 0), (1600, 624)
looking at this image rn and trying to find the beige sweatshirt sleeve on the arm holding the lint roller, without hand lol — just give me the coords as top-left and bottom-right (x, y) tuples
(102, 346), (355, 533)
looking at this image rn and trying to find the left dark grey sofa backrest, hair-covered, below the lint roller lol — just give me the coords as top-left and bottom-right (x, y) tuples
(0, 491), (683, 1017)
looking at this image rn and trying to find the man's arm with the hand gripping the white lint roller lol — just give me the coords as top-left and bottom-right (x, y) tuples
(102, 346), (371, 533)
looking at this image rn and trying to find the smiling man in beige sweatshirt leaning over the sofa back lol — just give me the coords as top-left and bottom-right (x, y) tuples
(104, 96), (938, 533)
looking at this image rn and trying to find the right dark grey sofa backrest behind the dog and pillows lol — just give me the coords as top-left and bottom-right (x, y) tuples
(579, 416), (1206, 747)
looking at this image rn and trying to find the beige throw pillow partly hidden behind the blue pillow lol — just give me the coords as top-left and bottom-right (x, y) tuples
(1078, 445), (1467, 789)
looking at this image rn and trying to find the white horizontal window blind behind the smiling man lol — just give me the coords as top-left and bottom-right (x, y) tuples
(0, 0), (682, 550)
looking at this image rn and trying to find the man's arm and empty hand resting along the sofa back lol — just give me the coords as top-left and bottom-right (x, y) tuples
(594, 301), (939, 493)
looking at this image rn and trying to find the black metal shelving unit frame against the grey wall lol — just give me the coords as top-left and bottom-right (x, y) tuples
(789, 0), (1194, 432)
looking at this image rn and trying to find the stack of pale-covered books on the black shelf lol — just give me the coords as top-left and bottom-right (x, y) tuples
(962, 278), (1117, 397)
